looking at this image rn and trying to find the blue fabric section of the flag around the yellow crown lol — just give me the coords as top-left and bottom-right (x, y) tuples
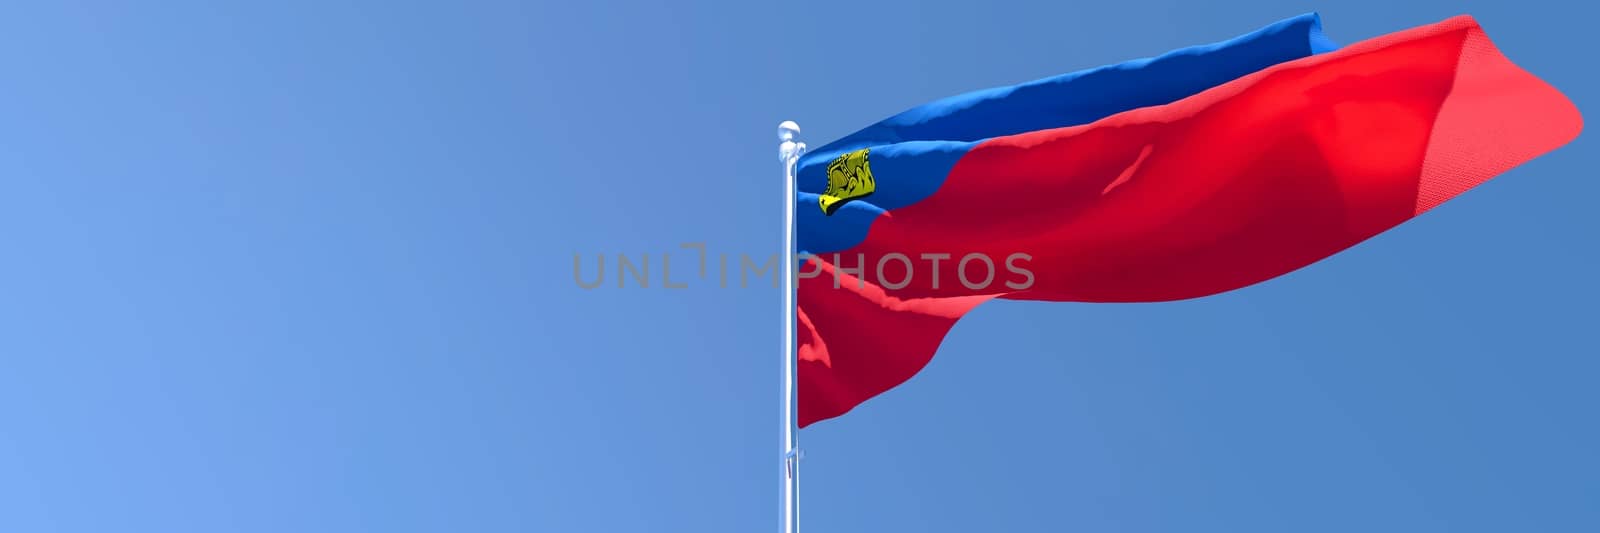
(795, 13), (1338, 253)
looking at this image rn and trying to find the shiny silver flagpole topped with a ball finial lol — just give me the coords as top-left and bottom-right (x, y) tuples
(778, 120), (805, 533)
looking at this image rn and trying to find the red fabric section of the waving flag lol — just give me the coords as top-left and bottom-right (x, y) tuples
(798, 16), (1582, 427)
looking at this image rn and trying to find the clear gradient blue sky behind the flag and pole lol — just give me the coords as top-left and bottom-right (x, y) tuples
(0, 0), (1600, 533)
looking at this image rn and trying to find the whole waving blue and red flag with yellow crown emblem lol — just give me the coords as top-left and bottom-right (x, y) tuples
(795, 14), (1582, 427)
